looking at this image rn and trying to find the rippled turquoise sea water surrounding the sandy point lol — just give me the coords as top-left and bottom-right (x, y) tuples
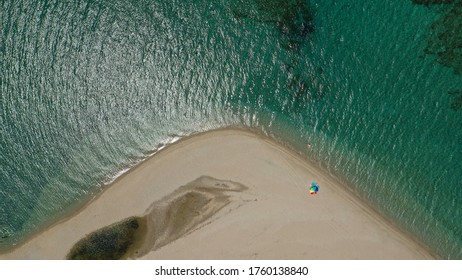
(0, 0), (462, 259)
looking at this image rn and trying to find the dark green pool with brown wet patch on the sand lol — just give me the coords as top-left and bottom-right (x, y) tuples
(67, 176), (247, 260)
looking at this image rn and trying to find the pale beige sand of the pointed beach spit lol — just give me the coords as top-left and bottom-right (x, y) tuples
(0, 129), (433, 259)
